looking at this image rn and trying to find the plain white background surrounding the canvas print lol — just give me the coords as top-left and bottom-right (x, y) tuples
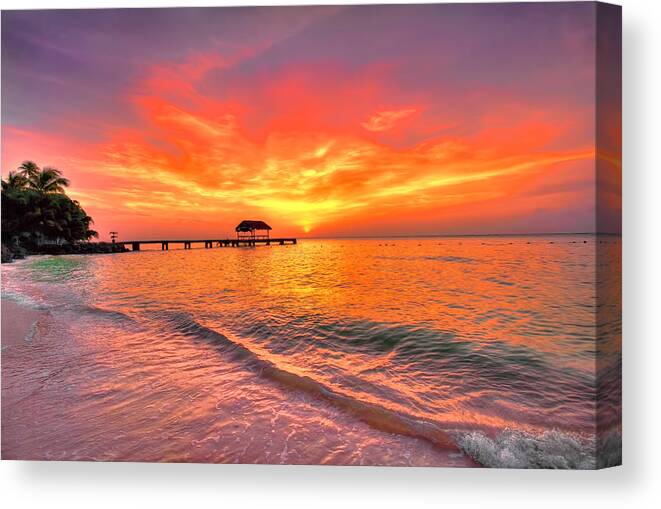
(0, 0), (661, 509)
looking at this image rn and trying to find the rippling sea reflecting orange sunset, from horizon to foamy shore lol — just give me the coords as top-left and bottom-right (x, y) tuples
(2, 235), (621, 468)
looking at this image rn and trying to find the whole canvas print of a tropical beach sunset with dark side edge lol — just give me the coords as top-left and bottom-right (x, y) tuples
(2, 2), (622, 469)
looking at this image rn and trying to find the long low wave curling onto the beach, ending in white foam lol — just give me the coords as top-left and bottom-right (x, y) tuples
(152, 313), (621, 470)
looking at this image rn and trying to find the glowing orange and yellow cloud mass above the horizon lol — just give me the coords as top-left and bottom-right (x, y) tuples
(3, 51), (595, 238)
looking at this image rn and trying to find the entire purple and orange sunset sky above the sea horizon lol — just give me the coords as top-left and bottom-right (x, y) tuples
(2, 3), (620, 239)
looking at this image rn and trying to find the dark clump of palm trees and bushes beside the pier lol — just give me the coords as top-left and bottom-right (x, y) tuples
(2, 161), (123, 262)
